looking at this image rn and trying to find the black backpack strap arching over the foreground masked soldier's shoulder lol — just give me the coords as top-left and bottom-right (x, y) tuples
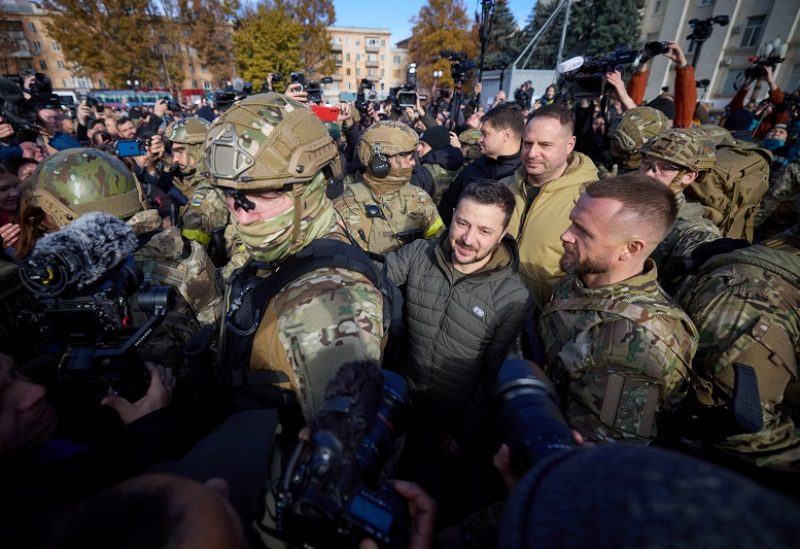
(217, 239), (403, 409)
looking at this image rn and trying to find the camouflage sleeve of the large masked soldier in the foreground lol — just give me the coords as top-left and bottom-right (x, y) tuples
(270, 268), (383, 421)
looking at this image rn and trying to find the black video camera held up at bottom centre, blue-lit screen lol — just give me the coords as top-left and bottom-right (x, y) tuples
(276, 362), (408, 548)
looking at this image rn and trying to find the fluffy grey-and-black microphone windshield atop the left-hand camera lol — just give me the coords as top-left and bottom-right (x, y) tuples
(20, 212), (139, 296)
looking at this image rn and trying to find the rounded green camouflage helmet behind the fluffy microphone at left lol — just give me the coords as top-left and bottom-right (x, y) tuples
(30, 149), (145, 227)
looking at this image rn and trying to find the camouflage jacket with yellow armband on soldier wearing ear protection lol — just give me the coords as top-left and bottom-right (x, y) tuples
(333, 179), (444, 254)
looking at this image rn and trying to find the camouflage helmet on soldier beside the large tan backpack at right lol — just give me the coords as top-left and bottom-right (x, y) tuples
(641, 128), (717, 172)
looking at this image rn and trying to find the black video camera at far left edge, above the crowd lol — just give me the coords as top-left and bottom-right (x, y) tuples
(0, 69), (53, 134)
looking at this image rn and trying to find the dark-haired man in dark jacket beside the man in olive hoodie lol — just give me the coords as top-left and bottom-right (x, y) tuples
(439, 103), (525, 226)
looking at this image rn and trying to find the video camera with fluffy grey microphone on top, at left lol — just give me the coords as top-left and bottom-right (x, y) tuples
(20, 212), (175, 401)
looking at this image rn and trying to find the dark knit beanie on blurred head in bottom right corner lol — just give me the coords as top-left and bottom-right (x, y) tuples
(497, 443), (800, 549)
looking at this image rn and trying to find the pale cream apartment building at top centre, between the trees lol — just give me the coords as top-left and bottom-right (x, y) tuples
(323, 26), (408, 103)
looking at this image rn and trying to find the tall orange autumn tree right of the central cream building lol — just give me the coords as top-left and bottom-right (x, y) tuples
(408, 0), (479, 88)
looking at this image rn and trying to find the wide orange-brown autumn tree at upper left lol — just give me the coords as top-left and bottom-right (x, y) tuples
(42, 0), (183, 87)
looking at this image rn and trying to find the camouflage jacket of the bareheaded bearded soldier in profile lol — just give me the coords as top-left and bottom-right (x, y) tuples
(539, 259), (697, 444)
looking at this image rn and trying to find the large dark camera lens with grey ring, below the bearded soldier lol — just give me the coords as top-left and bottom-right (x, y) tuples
(493, 359), (576, 473)
